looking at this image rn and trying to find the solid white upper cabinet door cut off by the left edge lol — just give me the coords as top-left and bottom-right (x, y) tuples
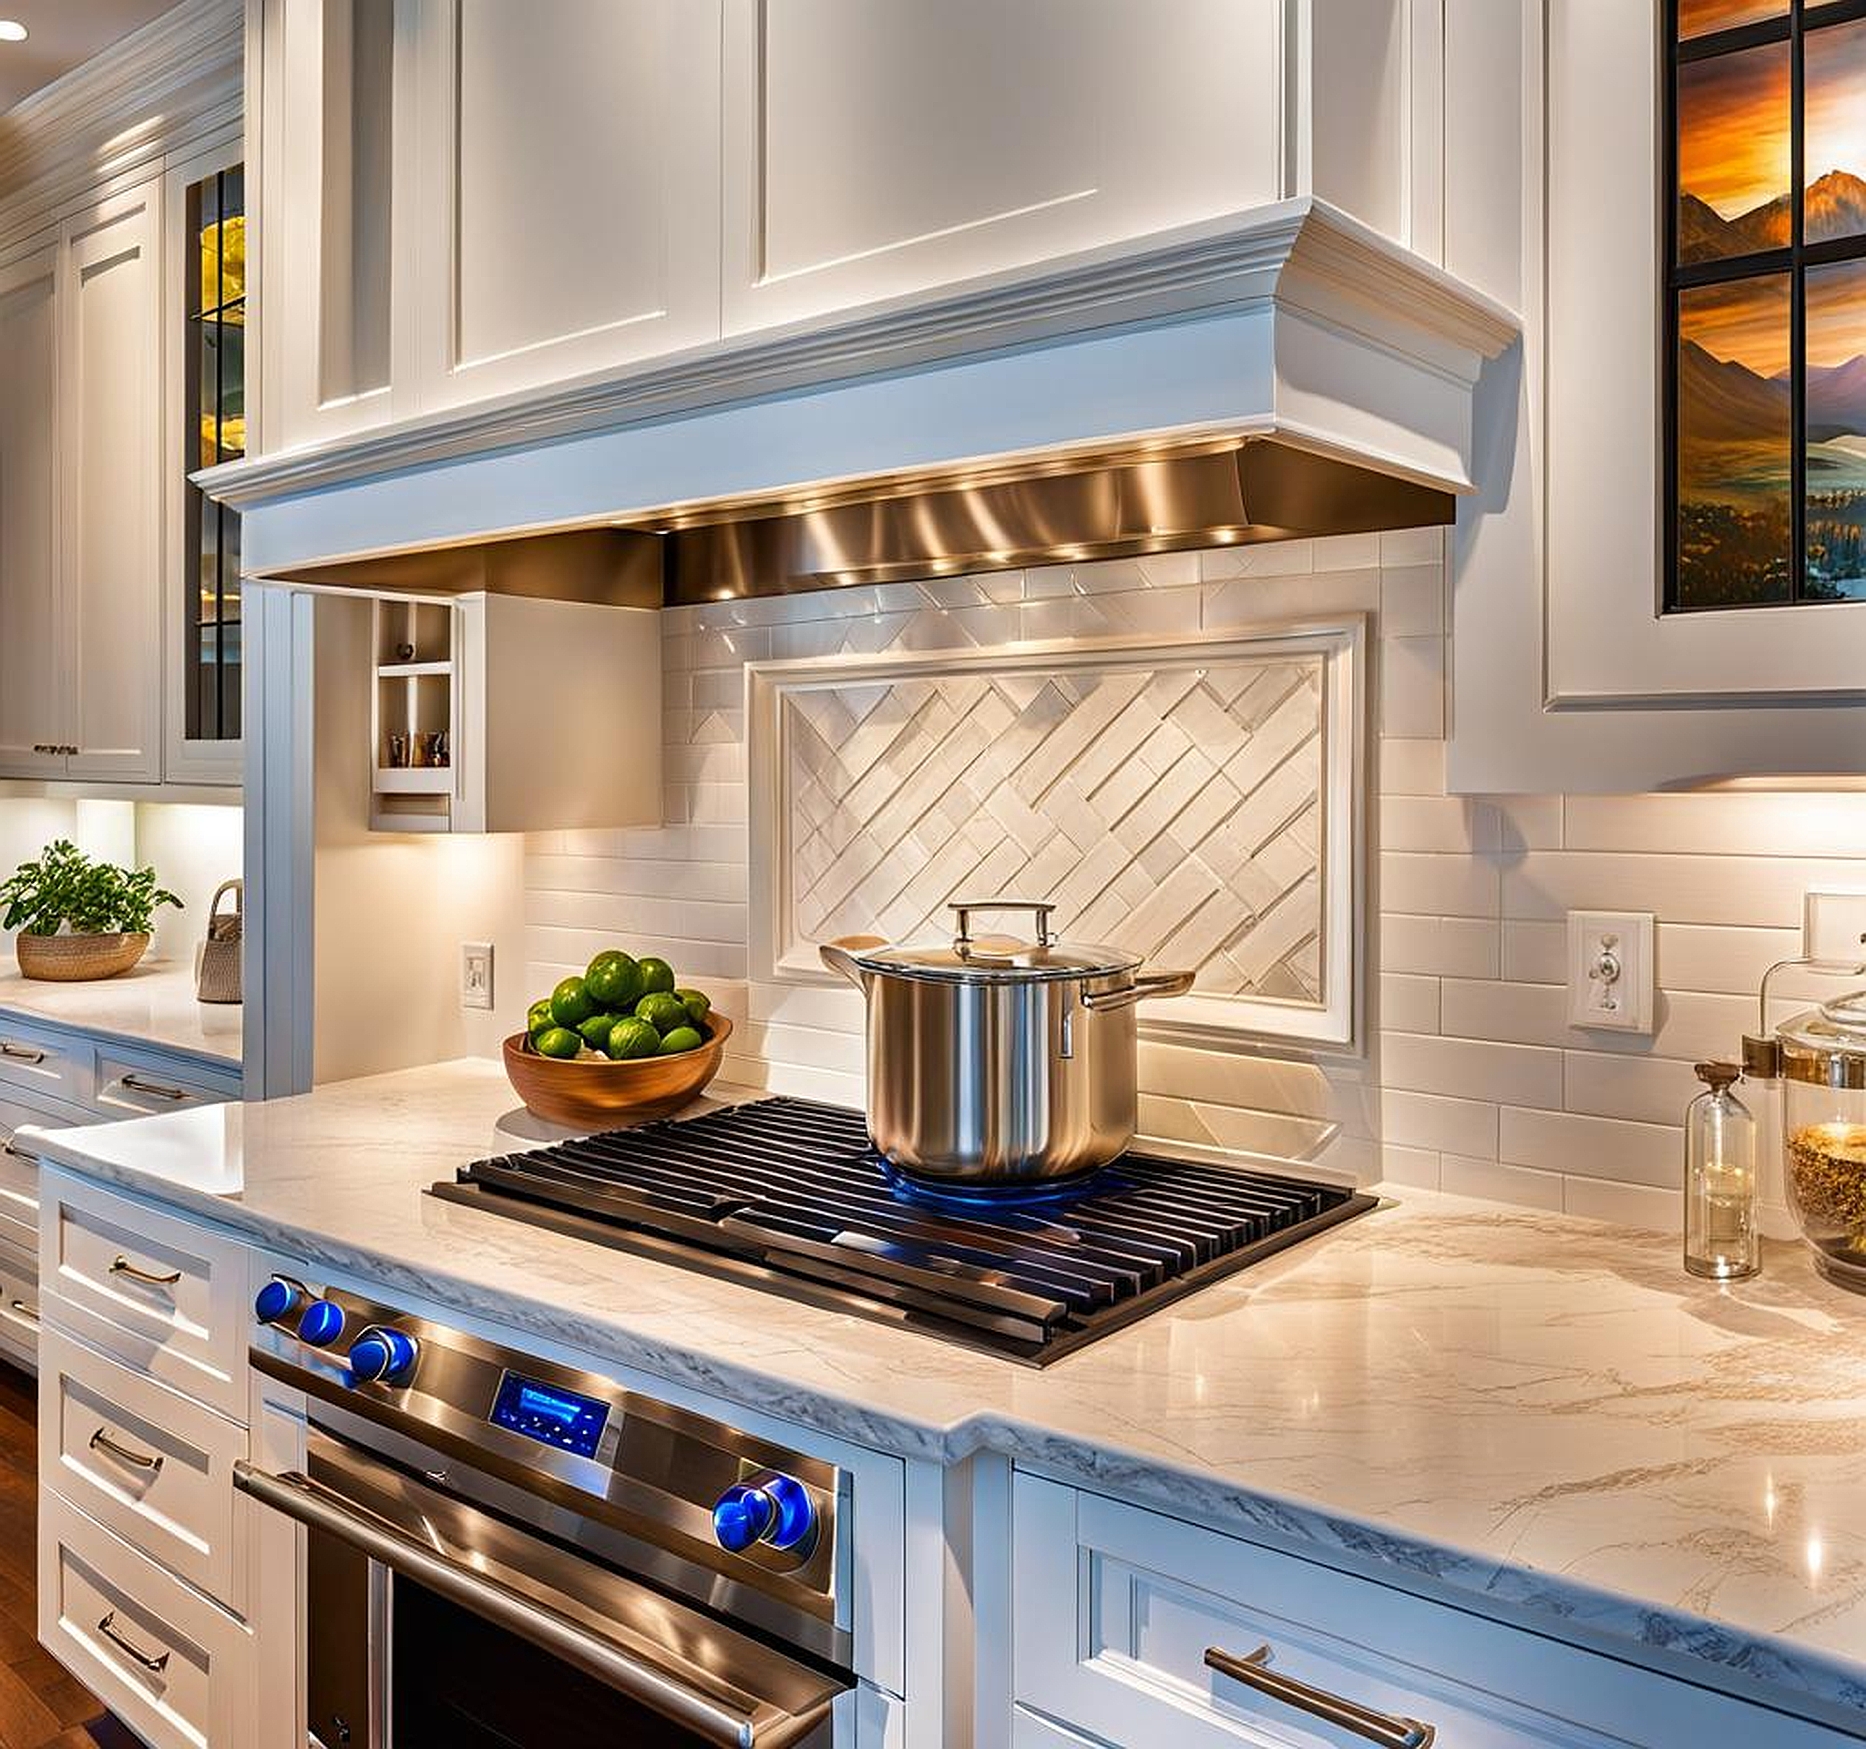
(0, 248), (71, 777)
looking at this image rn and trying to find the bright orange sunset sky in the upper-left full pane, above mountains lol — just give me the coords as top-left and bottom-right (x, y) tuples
(1678, 43), (1791, 218)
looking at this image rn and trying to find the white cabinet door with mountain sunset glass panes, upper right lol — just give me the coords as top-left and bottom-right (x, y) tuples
(1543, 0), (1866, 713)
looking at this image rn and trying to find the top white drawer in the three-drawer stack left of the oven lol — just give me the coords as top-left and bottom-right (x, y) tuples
(39, 1170), (246, 1424)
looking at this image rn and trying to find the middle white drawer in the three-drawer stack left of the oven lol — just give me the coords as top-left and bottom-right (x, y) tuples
(39, 1331), (246, 1615)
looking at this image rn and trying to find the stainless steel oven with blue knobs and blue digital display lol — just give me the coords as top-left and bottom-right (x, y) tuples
(235, 1277), (855, 1749)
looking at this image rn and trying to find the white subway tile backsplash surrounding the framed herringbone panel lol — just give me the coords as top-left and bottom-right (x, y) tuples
(526, 528), (1866, 1230)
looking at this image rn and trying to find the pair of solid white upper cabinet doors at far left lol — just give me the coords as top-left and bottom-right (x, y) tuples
(0, 181), (162, 782)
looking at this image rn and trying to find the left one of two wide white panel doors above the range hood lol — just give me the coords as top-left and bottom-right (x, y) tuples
(409, 0), (720, 411)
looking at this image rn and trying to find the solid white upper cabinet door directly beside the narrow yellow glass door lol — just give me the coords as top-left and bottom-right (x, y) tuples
(60, 181), (168, 782)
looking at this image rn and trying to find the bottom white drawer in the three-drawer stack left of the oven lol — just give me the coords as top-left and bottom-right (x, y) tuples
(39, 1490), (254, 1749)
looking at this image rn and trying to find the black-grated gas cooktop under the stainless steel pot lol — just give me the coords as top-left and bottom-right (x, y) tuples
(431, 1099), (1375, 1366)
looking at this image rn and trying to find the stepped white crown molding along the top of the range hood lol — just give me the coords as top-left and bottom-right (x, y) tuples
(194, 196), (1517, 523)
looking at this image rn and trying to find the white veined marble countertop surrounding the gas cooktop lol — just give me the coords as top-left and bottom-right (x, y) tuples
(34, 1060), (1866, 1710)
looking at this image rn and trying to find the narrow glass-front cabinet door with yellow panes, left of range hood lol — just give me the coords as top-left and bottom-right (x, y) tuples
(166, 142), (248, 784)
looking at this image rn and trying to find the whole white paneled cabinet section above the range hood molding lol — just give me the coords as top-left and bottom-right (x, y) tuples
(258, 0), (1441, 452)
